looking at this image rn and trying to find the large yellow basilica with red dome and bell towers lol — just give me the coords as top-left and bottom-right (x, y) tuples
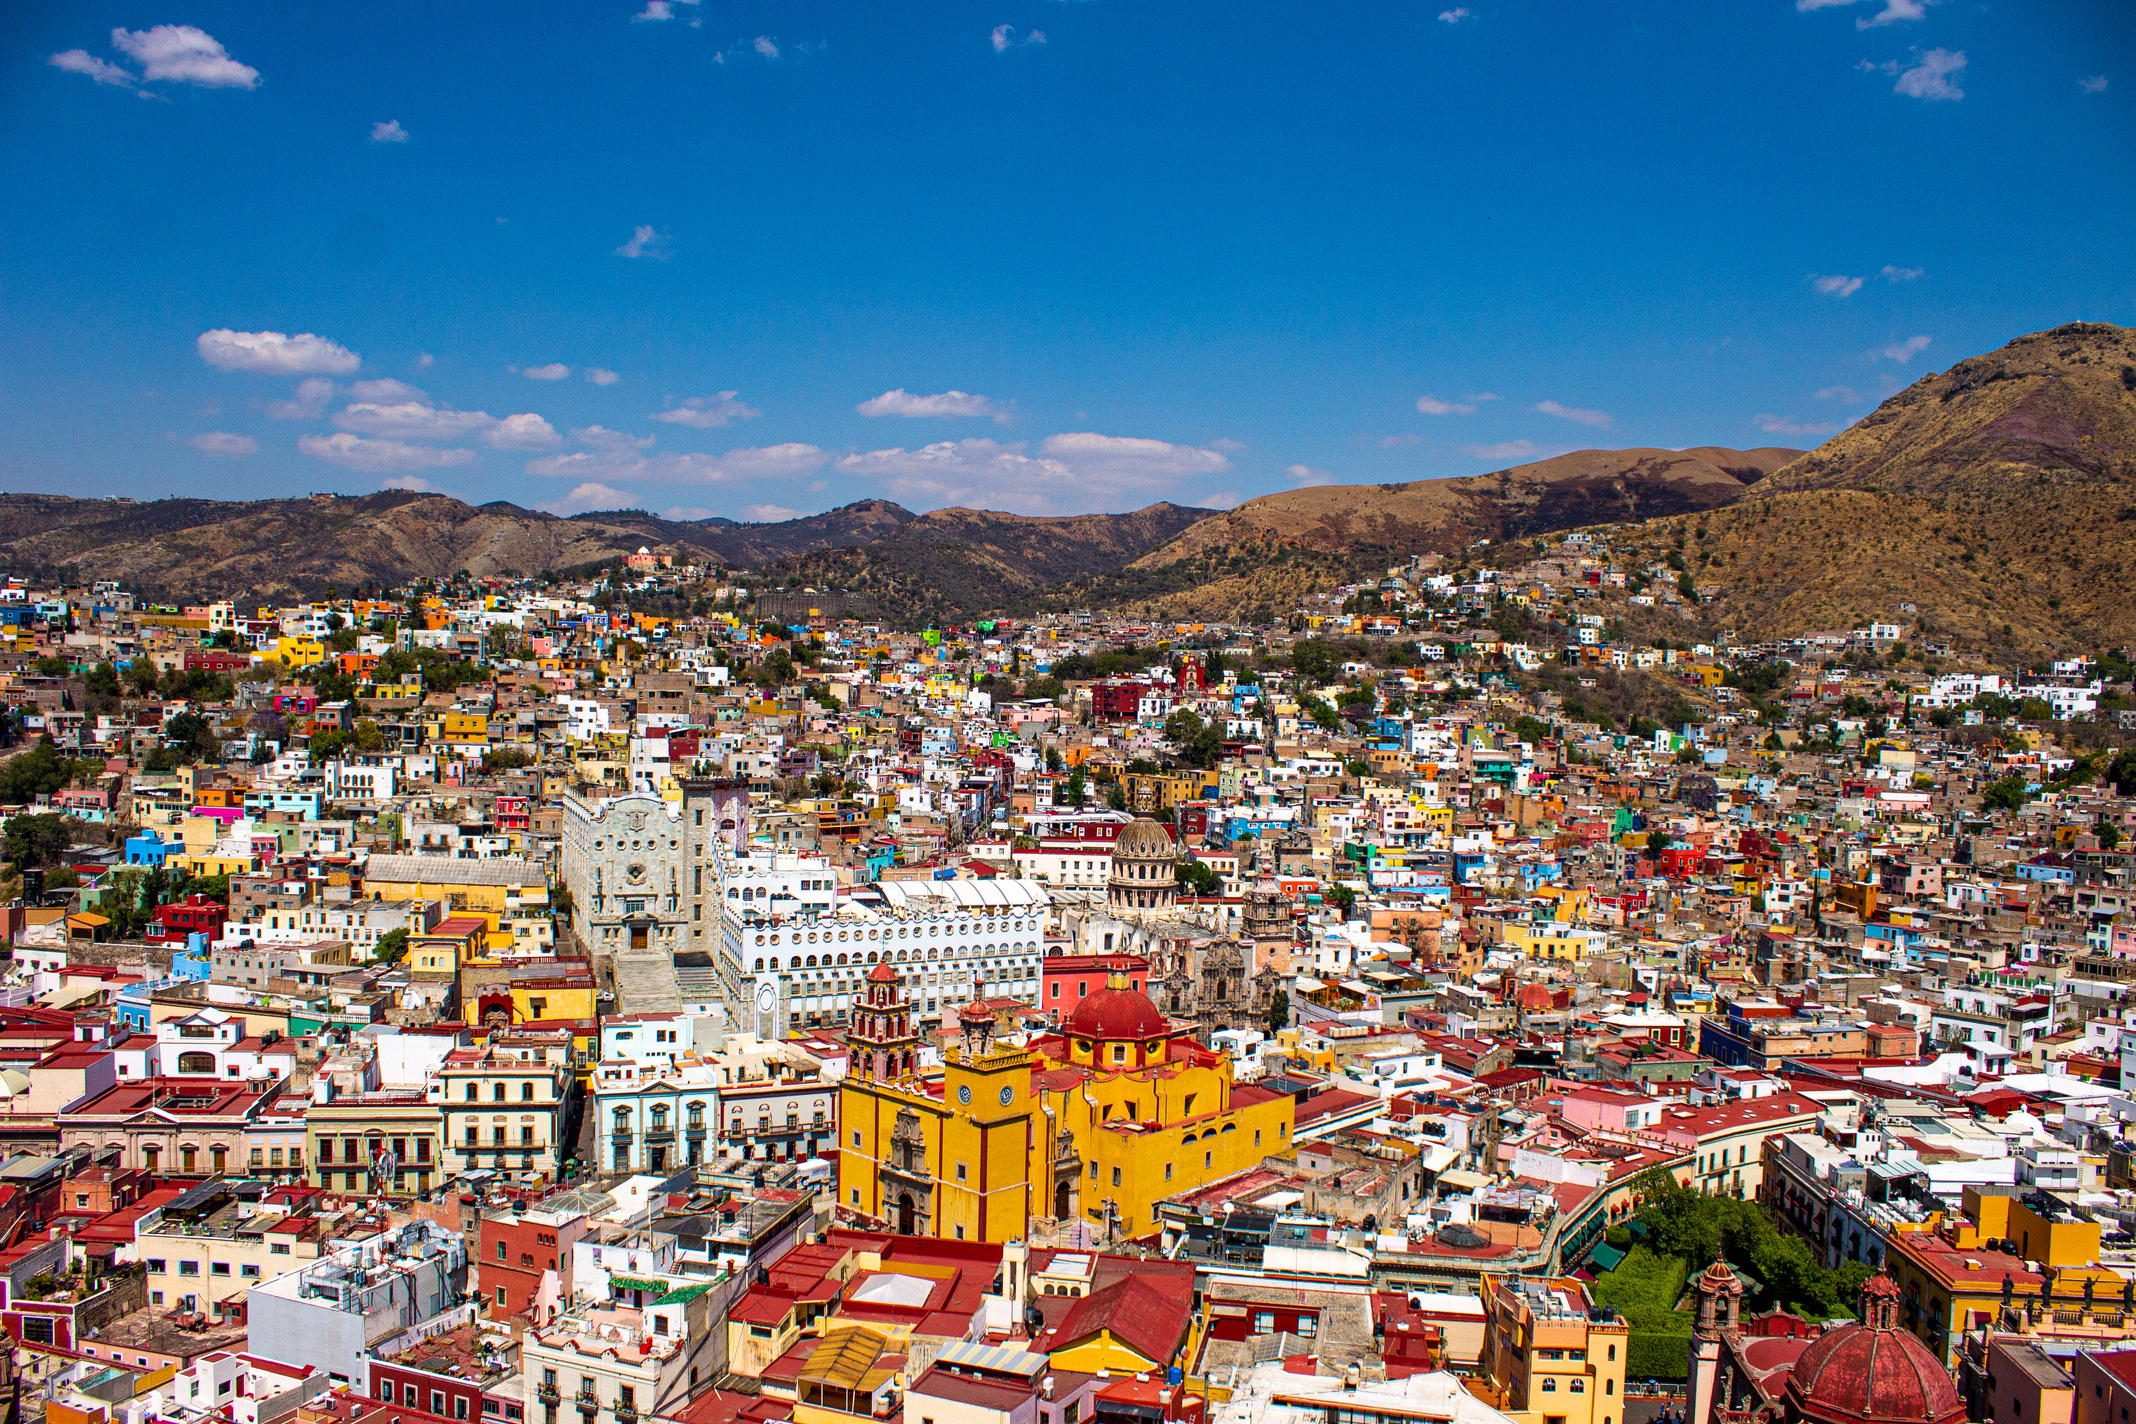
(837, 965), (1294, 1240)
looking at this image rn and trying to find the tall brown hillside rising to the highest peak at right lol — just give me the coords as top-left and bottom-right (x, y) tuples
(1614, 322), (2136, 649)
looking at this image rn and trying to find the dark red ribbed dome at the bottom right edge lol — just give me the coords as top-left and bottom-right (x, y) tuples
(1788, 1275), (1965, 1424)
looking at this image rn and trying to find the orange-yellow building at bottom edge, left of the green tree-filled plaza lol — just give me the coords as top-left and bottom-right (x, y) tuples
(1472, 1275), (1632, 1424)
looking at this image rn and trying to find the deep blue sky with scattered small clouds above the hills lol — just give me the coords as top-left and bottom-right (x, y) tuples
(0, 0), (2136, 519)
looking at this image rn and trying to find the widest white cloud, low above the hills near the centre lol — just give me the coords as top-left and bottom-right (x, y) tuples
(837, 431), (1230, 515)
